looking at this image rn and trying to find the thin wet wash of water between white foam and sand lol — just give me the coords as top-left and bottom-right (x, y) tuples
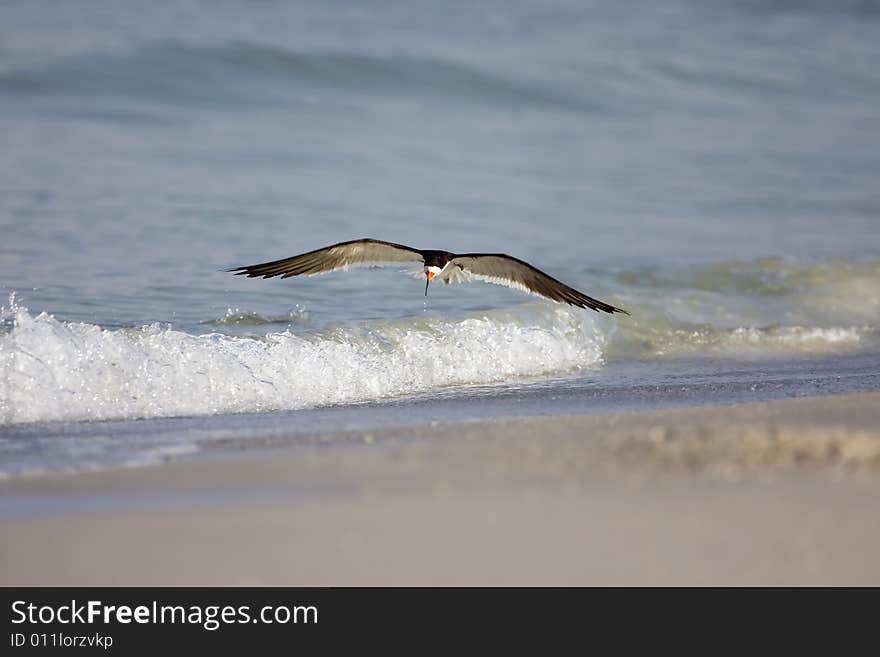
(6, 354), (880, 478)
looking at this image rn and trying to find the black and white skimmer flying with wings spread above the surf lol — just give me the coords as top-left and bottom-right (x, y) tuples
(227, 239), (629, 315)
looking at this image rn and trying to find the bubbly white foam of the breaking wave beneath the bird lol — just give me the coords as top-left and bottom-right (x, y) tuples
(0, 304), (606, 424)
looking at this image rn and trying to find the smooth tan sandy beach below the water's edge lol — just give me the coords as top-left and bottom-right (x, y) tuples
(0, 393), (880, 586)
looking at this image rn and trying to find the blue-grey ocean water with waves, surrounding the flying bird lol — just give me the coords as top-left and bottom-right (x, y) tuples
(0, 0), (880, 474)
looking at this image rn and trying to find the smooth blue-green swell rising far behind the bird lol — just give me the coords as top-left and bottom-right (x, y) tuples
(0, 42), (606, 113)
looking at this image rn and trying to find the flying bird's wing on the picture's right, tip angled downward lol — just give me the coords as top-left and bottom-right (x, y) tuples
(442, 253), (629, 315)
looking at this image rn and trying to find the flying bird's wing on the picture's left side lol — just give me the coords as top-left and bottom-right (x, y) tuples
(227, 239), (424, 278)
